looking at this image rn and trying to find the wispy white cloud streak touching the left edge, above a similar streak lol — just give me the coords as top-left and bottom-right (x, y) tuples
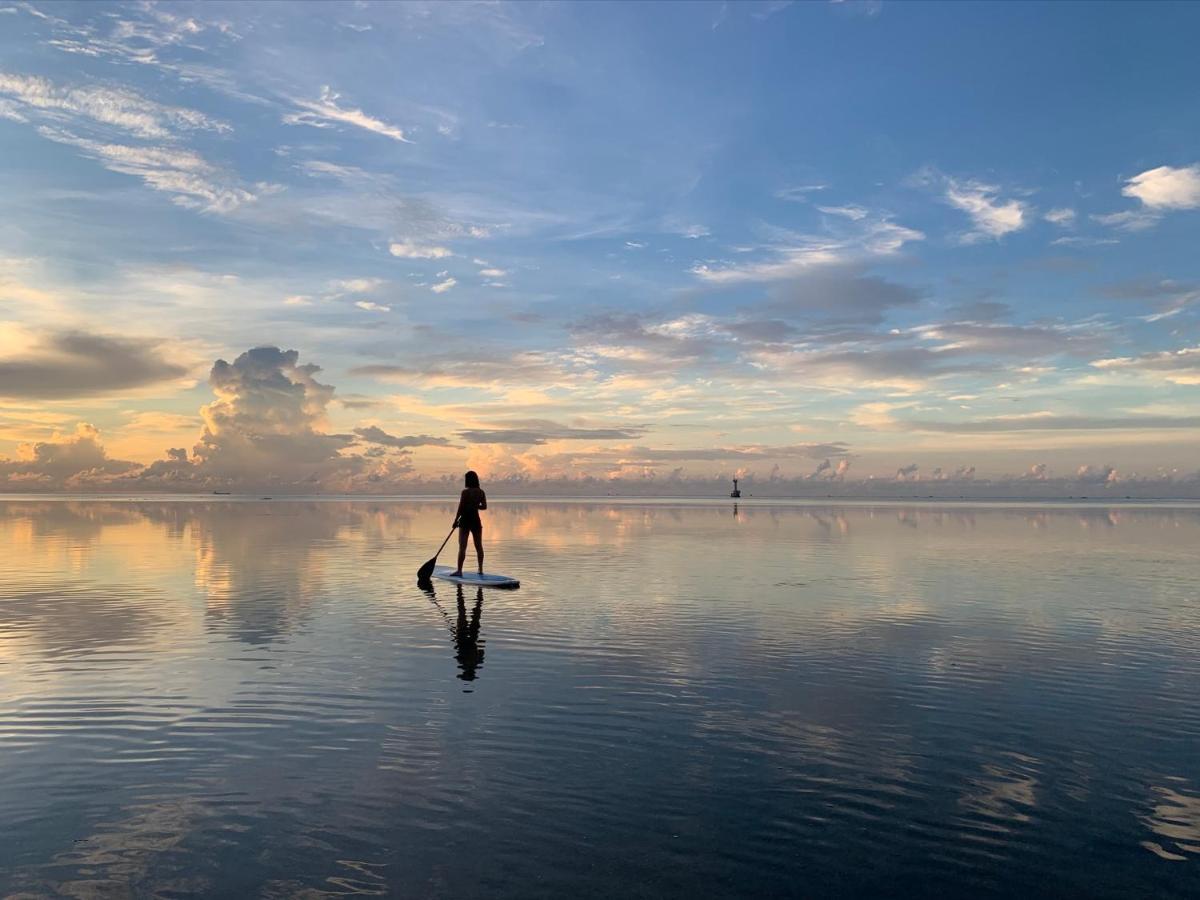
(0, 72), (230, 139)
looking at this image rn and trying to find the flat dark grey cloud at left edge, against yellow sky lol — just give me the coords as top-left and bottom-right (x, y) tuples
(0, 331), (187, 400)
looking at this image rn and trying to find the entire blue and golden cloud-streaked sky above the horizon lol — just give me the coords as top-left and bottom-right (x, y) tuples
(0, 0), (1200, 496)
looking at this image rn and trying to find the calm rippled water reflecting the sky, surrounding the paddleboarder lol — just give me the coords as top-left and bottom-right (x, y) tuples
(0, 500), (1200, 898)
